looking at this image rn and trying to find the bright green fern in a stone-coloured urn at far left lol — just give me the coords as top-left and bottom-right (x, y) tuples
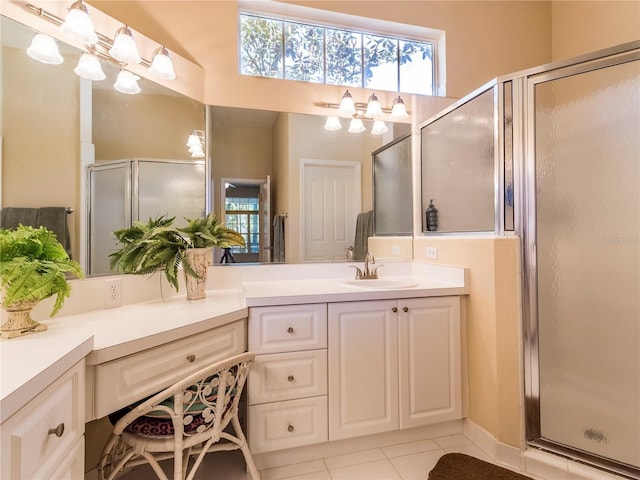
(0, 225), (84, 338)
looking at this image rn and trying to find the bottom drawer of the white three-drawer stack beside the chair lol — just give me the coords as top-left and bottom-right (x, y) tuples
(249, 396), (328, 454)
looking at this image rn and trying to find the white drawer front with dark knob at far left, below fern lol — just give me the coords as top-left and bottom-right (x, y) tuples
(0, 360), (85, 480)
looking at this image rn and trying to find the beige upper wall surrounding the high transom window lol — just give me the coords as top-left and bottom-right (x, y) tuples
(89, 0), (551, 113)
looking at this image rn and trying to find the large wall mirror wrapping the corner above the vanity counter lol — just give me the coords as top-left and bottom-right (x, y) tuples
(1, 17), (410, 275)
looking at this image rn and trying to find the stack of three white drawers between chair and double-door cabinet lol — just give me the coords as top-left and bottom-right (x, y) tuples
(247, 303), (328, 453)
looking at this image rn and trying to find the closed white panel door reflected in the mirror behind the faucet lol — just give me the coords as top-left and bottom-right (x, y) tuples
(301, 160), (361, 262)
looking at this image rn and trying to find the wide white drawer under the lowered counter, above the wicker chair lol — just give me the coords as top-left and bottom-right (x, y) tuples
(94, 321), (246, 418)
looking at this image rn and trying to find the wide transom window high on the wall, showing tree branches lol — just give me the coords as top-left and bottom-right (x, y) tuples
(240, 13), (435, 95)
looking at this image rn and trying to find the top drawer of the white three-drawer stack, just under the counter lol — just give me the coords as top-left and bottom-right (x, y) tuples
(249, 303), (327, 353)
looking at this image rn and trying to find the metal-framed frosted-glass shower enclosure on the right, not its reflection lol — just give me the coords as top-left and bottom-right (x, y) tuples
(421, 41), (640, 478)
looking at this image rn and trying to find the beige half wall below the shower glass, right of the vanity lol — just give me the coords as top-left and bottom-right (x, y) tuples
(414, 237), (522, 447)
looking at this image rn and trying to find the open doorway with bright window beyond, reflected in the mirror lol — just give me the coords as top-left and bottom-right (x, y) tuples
(219, 177), (271, 263)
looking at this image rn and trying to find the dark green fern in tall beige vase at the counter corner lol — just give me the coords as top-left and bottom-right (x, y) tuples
(110, 213), (245, 300)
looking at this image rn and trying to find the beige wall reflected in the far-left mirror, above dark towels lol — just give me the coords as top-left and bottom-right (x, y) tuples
(1, 48), (80, 258)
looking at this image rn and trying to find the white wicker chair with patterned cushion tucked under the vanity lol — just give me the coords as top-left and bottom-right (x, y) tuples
(98, 353), (260, 480)
